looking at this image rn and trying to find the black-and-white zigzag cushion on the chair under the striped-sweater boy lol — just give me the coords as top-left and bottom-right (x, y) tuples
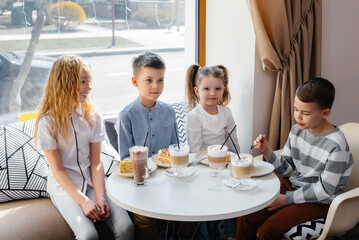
(284, 218), (325, 240)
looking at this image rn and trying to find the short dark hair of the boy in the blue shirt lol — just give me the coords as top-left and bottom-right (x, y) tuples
(132, 52), (166, 75)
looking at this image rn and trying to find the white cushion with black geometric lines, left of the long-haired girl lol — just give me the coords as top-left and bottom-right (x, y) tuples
(0, 120), (48, 202)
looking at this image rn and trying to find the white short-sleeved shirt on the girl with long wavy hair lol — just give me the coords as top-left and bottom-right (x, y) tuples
(37, 109), (105, 196)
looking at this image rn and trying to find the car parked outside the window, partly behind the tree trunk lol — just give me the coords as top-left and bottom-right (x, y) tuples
(0, 48), (55, 124)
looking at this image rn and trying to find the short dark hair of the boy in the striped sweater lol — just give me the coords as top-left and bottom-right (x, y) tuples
(296, 78), (335, 109)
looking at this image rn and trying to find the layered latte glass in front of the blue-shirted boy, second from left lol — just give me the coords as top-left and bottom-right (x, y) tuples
(168, 144), (189, 176)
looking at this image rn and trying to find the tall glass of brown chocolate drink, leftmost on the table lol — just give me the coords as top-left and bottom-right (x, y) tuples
(129, 146), (149, 185)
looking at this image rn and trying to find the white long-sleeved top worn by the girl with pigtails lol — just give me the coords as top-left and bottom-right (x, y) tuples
(187, 104), (240, 153)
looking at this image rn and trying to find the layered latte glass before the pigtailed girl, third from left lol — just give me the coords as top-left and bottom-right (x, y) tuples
(207, 145), (228, 177)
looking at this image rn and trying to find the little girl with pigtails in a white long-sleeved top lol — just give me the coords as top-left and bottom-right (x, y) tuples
(186, 64), (240, 153)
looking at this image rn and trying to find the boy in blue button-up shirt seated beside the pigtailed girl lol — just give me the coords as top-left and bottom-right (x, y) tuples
(116, 52), (177, 239)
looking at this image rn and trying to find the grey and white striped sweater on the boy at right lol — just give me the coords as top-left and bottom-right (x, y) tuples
(268, 125), (353, 205)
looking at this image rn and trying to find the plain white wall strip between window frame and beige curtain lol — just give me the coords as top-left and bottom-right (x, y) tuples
(206, 0), (255, 152)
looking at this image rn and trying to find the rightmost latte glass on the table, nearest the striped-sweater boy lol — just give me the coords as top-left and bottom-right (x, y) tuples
(230, 153), (253, 183)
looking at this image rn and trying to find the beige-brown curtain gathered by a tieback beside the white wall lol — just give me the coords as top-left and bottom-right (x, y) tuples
(250, 0), (322, 149)
